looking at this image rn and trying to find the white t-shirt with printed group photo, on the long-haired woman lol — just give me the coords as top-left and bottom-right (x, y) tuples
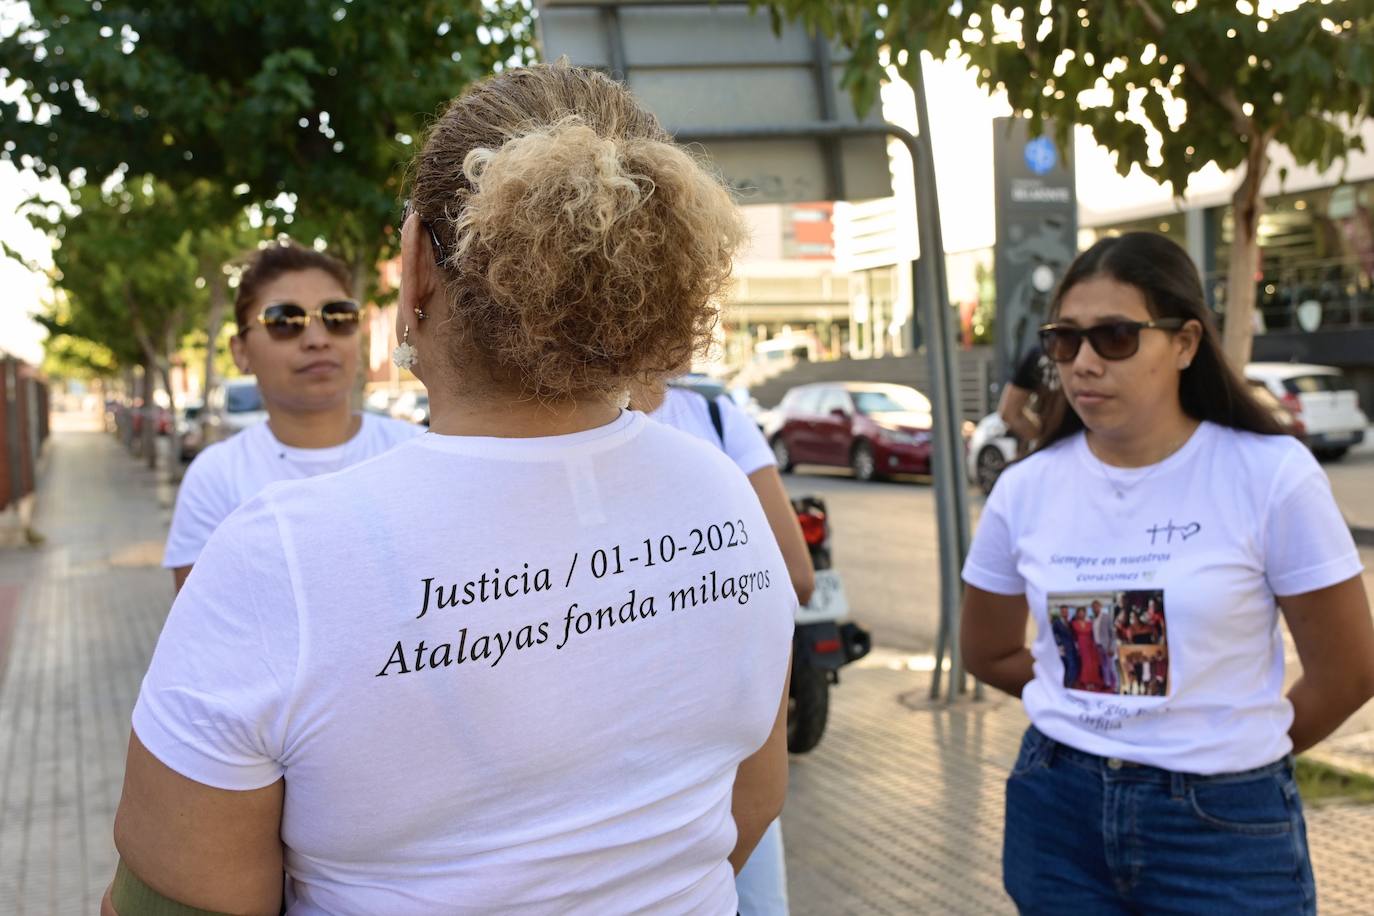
(963, 423), (1362, 775)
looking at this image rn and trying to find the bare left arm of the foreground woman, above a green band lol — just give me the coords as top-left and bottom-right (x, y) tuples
(102, 735), (286, 916)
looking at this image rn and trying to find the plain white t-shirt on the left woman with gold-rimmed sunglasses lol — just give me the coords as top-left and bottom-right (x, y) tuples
(162, 413), (425, 570)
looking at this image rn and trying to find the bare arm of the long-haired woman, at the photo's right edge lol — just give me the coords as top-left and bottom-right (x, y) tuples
(1279, 575), (1374, 753)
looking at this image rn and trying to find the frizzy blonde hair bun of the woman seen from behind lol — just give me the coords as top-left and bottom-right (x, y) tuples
(436, 115), (745, 397)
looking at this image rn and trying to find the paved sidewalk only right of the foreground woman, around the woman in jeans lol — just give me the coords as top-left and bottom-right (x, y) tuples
(783, 650), (1374, 916)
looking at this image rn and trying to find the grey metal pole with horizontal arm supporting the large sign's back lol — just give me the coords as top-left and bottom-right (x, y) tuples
(677, 118), (969, 700)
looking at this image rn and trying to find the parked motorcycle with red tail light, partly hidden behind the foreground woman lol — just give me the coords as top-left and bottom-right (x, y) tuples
(787, 496), (872, 754)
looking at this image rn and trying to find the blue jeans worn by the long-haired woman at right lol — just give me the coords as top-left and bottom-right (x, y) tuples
(1002, 726), (1316, 916)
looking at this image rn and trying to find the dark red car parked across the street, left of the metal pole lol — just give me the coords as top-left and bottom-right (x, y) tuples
(769, 382), (930, 481)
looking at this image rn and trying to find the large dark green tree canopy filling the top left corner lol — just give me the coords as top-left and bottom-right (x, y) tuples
(0, 0), (533, 304)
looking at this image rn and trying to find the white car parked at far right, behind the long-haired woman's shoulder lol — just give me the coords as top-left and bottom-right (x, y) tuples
(1245, 363), (1370, 460)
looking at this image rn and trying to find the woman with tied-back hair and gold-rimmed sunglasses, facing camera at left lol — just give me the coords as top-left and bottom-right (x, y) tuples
(162, 243), (423, 591)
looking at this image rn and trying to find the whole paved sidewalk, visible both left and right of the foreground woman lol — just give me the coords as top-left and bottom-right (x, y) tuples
(8, 431), (1374, 916)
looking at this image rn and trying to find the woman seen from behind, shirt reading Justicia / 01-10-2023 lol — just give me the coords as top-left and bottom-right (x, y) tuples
(106, 66), (797, 915)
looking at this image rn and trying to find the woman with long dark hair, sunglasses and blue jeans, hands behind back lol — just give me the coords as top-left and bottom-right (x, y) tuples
(962, 233), (1374, 913)
